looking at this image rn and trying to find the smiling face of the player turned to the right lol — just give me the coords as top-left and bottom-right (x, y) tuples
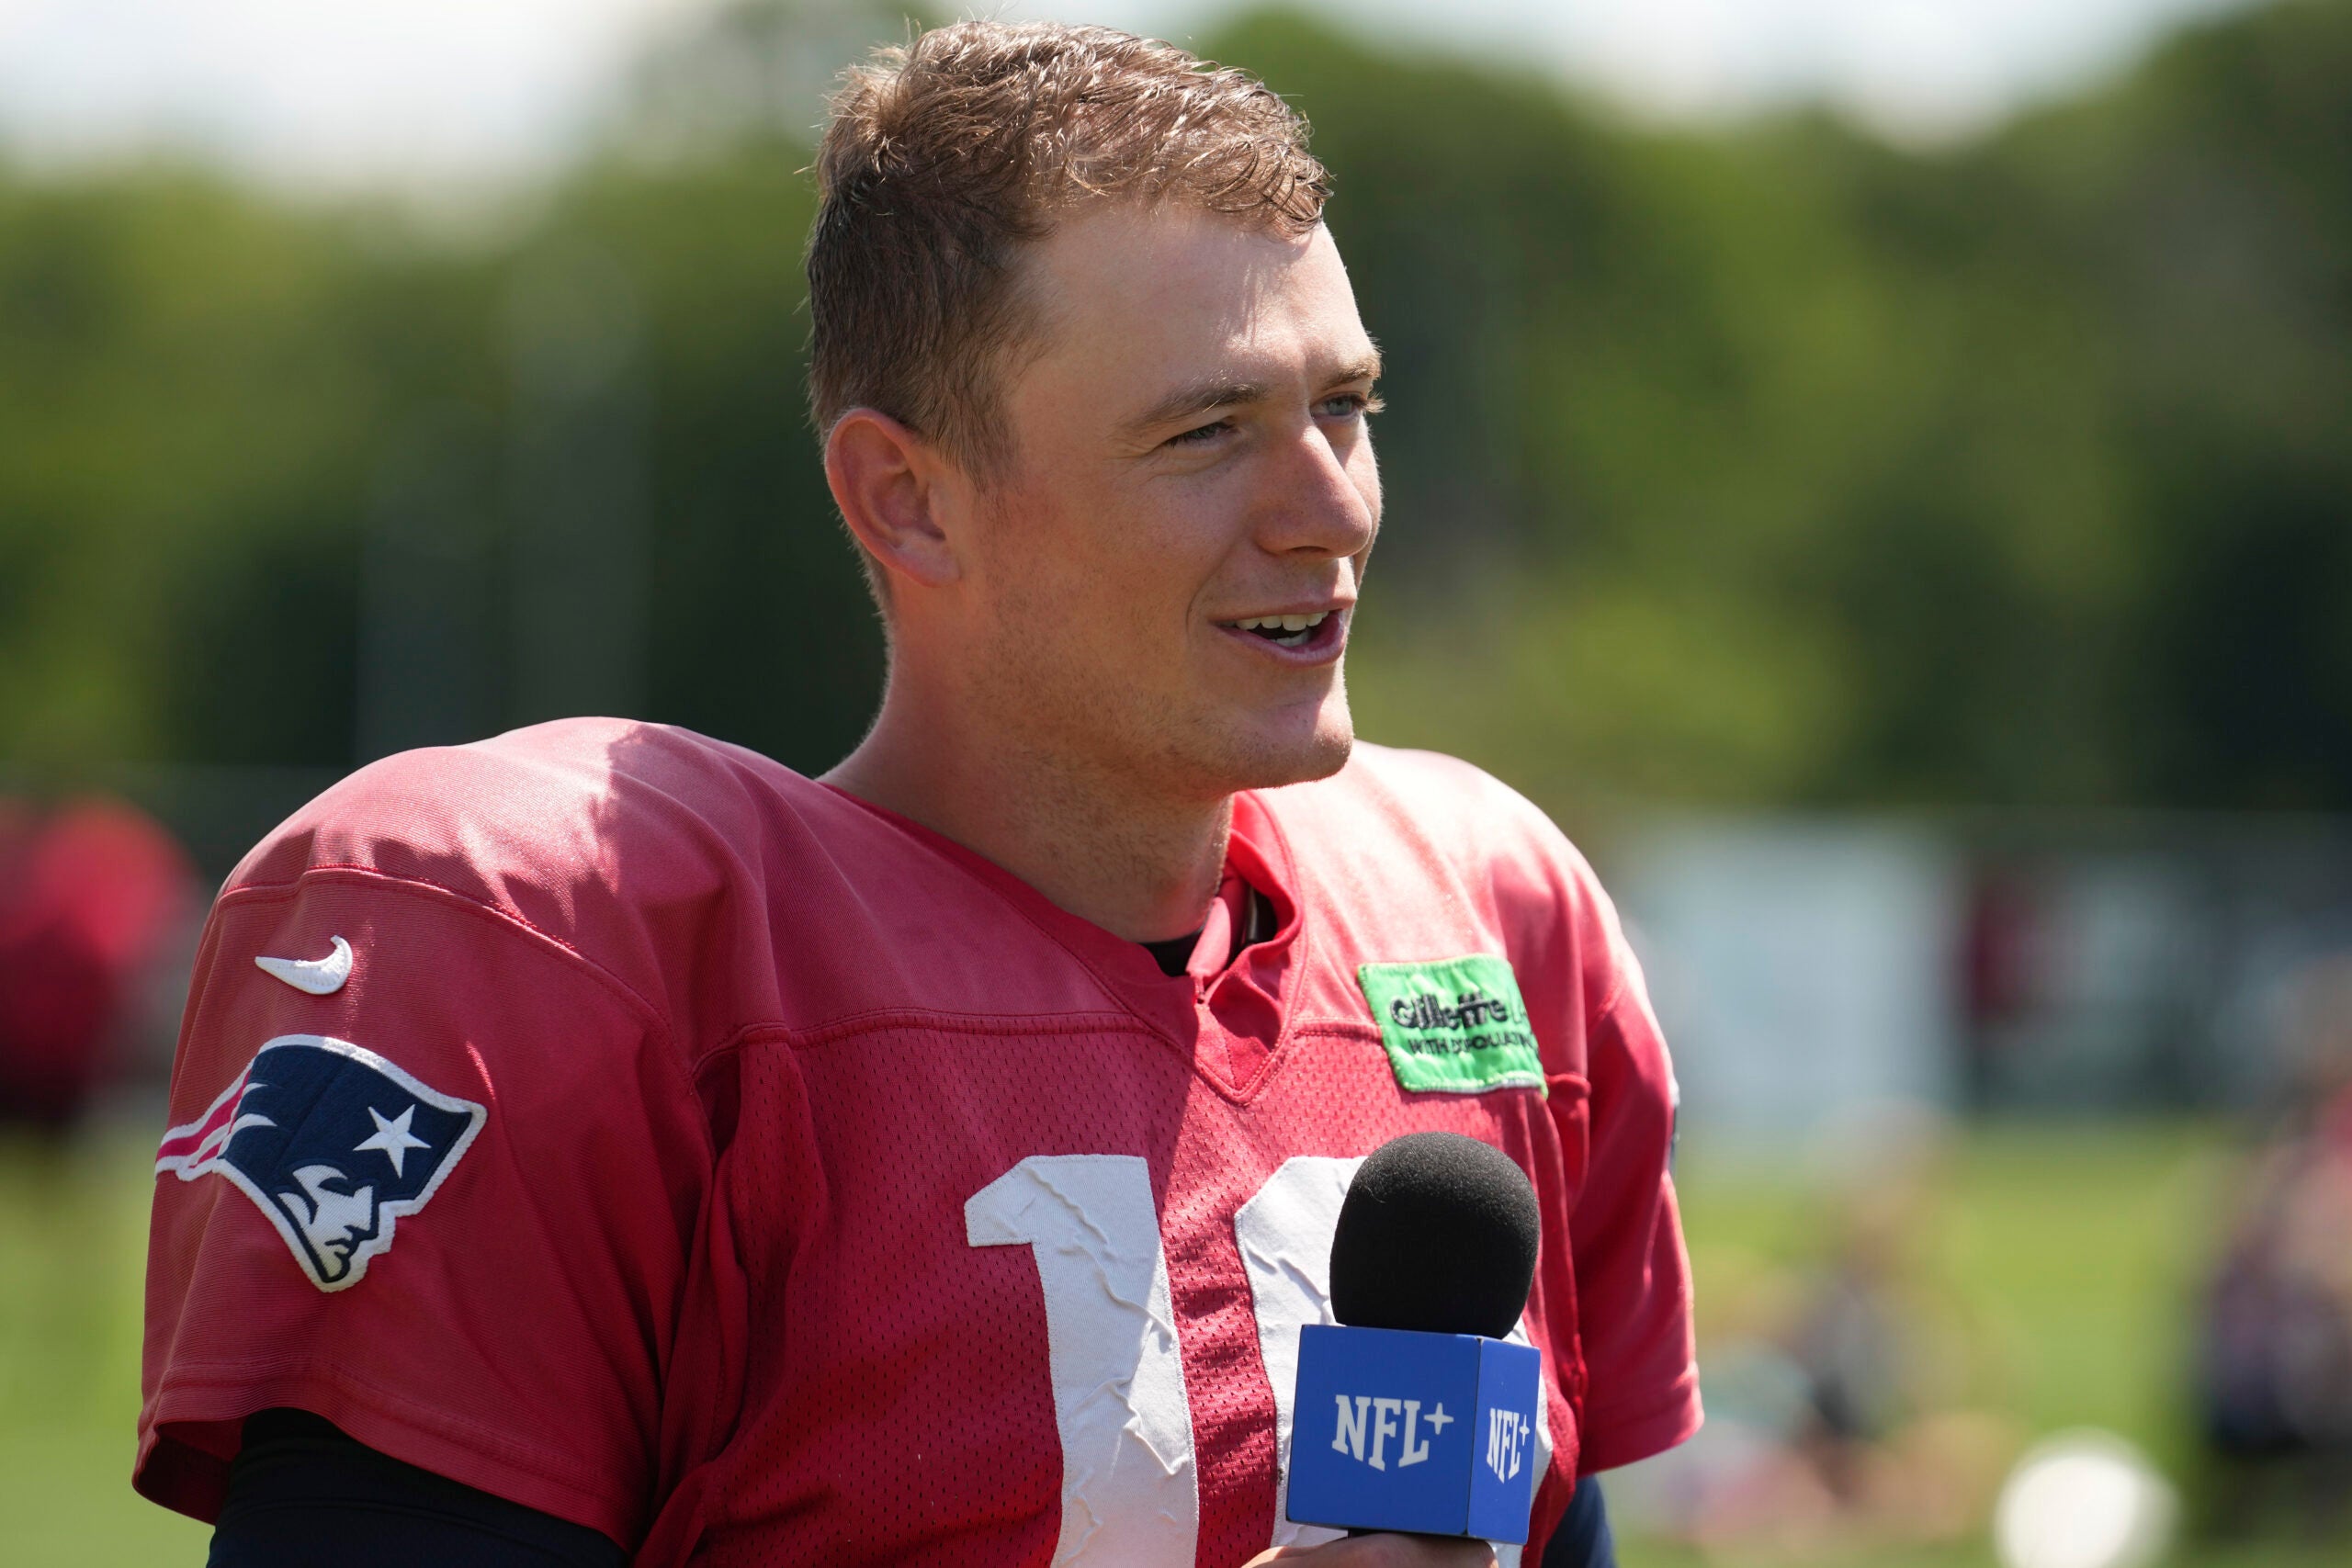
(967, 207), (1381, 797)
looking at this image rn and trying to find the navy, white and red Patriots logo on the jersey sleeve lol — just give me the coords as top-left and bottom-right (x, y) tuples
(155, 1034), (489, 1291)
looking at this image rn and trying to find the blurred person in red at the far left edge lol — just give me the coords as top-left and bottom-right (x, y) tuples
(0, 799), (198, 1134)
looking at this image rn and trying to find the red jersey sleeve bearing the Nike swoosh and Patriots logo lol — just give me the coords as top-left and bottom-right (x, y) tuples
(134, 867), (710, 1547)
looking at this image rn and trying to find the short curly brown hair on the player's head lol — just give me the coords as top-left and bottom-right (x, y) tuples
(807, 21), (1331, 478)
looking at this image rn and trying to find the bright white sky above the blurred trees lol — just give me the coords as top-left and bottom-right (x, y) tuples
(0, 0), (2248, 186)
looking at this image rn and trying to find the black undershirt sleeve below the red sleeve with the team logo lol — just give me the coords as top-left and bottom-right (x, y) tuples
(207, 1411), (628, 1568)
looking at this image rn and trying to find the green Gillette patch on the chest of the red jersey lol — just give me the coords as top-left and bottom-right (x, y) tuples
(1355, 952), (1543, 1096)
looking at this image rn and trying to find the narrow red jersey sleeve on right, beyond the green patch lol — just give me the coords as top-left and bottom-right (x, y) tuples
(1569, 907), (1701, 1474)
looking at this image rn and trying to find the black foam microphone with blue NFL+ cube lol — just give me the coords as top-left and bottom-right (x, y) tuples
(1289, 1134), (1543, 1542)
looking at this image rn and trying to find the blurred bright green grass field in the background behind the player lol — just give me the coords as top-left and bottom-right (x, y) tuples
(0, 1123), (2343, 1568)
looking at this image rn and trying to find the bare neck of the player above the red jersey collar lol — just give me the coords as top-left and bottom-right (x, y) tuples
(823, 680), (1232, 942)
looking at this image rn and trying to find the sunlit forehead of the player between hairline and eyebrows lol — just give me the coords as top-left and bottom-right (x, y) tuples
(1013, 205), (1371, 419)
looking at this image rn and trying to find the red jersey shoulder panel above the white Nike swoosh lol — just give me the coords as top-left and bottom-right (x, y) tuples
(219, 719), (1099, 1063)
